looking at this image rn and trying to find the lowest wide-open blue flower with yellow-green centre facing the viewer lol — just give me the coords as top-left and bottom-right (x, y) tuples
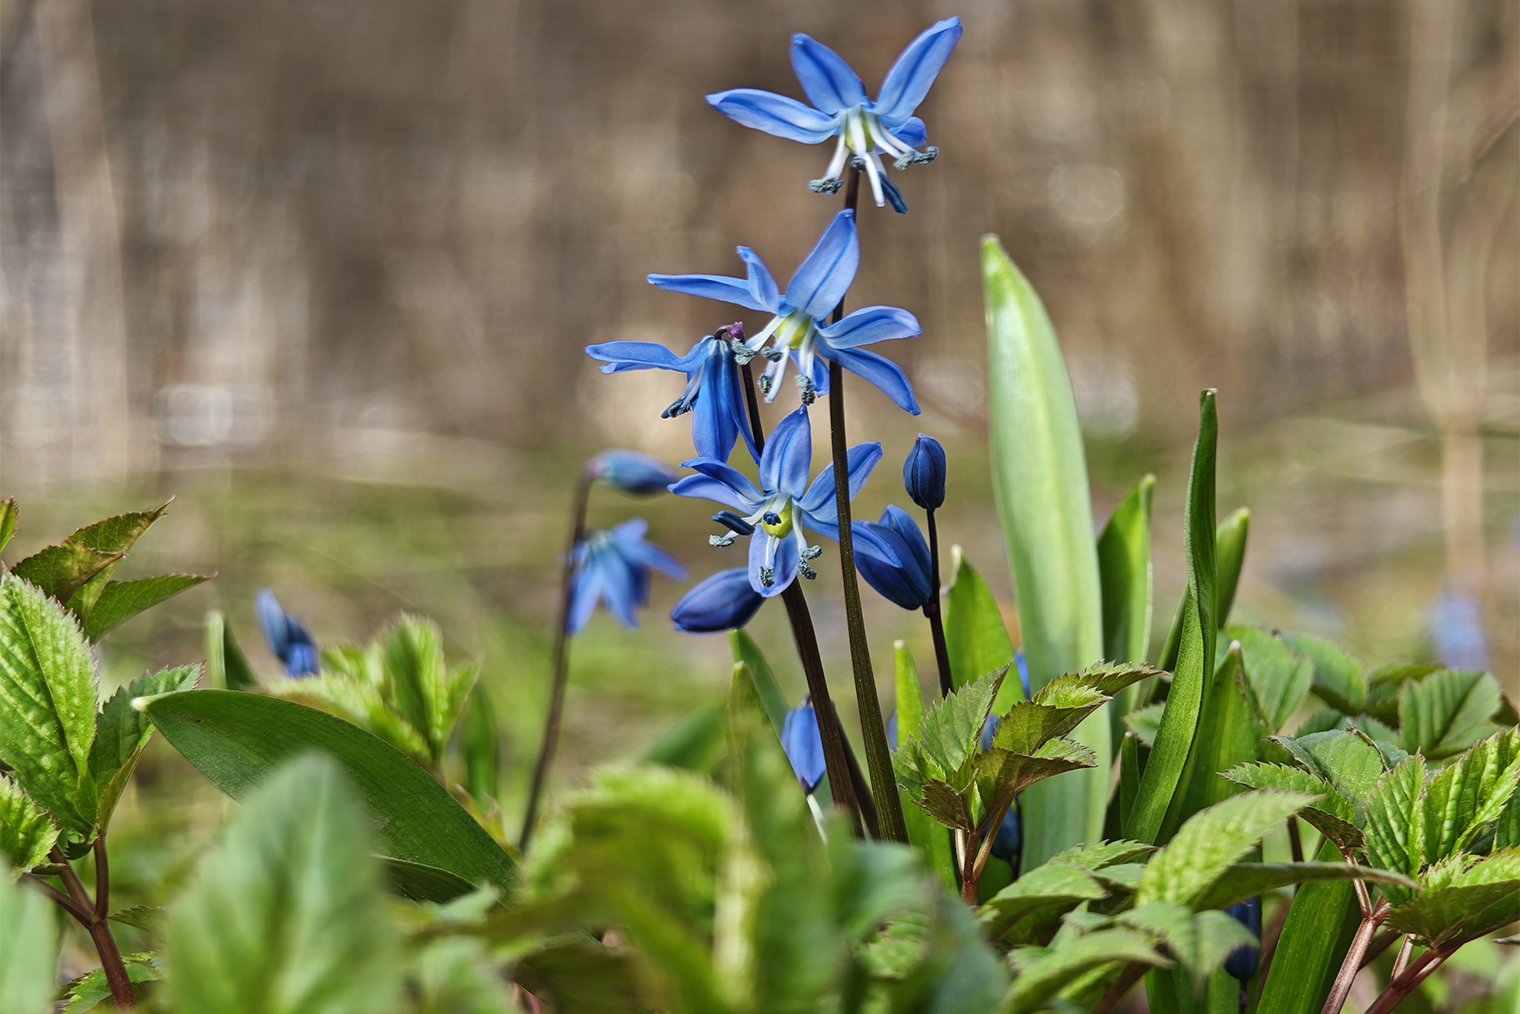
(670, 407), (892, 599)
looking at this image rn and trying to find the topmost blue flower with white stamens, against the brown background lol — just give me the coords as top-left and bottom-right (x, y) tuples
(707, 18), (961, 208)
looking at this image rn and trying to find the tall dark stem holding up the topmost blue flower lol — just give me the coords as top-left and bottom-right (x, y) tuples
(828, 166), (907, 844)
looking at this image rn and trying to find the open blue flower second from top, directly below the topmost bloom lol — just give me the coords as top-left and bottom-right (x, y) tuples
(647, 210), (921, 413)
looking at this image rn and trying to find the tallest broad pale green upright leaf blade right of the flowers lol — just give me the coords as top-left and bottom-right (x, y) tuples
(982, 236), (1113, 871)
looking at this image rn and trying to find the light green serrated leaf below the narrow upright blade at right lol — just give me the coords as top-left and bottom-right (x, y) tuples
(1135, 791), (1315, 905)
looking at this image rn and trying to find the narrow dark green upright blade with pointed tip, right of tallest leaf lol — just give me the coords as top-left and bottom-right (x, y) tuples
(1125, 391), (1219, 844)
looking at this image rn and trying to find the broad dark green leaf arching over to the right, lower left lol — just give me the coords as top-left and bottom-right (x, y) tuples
(146, 690), (515, 898)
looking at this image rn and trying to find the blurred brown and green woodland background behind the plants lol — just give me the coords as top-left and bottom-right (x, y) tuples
(0, 0), (1520, 942)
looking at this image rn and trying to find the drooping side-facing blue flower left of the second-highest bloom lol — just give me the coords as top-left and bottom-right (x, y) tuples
(585, 324), (755, 461)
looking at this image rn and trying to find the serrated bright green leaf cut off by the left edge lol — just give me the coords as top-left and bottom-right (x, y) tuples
(0, 573), (96, 839)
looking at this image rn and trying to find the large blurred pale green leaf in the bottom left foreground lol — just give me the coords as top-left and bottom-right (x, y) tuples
(168, 754), (400, 1014)
